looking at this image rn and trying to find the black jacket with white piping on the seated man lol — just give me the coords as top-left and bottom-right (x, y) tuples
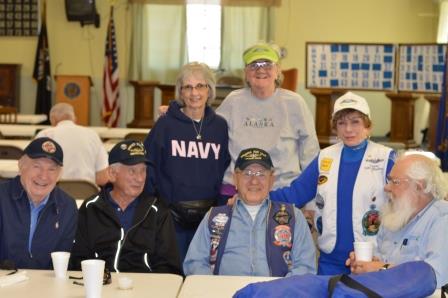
(70, 185), (181, 274)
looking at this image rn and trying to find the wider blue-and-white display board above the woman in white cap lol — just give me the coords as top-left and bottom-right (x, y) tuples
(306, 42), (396, 91)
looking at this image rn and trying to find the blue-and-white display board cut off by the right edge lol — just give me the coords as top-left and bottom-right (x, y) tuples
(398, 44), (447, 93)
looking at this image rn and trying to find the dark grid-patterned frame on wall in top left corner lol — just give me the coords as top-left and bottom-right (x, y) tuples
(0, 0), (39, 36)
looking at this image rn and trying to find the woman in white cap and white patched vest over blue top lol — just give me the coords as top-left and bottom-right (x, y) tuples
(270, 92), (395, 275)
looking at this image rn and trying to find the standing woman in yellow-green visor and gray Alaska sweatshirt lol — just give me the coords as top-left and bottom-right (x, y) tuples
(216, 43), (319, 197)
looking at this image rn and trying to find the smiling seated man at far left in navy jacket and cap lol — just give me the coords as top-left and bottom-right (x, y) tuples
(0, 138), (77, 269)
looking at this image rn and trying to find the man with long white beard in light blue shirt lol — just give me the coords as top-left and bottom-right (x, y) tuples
(346, 154), (448, 288)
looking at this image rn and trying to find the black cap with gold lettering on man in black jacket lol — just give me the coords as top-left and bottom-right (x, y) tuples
(109, 140), (148, 166)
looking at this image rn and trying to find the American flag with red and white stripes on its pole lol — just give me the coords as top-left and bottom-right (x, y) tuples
(102, 6), (120, 127)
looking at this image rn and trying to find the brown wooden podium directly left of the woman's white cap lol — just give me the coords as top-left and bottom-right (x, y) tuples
(310, 89), (347, 148)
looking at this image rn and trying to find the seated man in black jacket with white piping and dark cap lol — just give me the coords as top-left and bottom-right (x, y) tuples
(70, 140), (181, 273)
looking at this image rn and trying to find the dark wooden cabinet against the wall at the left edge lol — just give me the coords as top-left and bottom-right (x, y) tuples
(0, 64), (20, 111)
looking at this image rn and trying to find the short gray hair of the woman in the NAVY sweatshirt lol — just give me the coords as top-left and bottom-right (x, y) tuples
(175, 62), (216, 106)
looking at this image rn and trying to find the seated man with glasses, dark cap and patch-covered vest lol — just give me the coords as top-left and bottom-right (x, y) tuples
(184, 148), (316, 277)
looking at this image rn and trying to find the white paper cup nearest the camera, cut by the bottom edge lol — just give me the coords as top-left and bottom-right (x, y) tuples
(81, 260), (105, 298)
